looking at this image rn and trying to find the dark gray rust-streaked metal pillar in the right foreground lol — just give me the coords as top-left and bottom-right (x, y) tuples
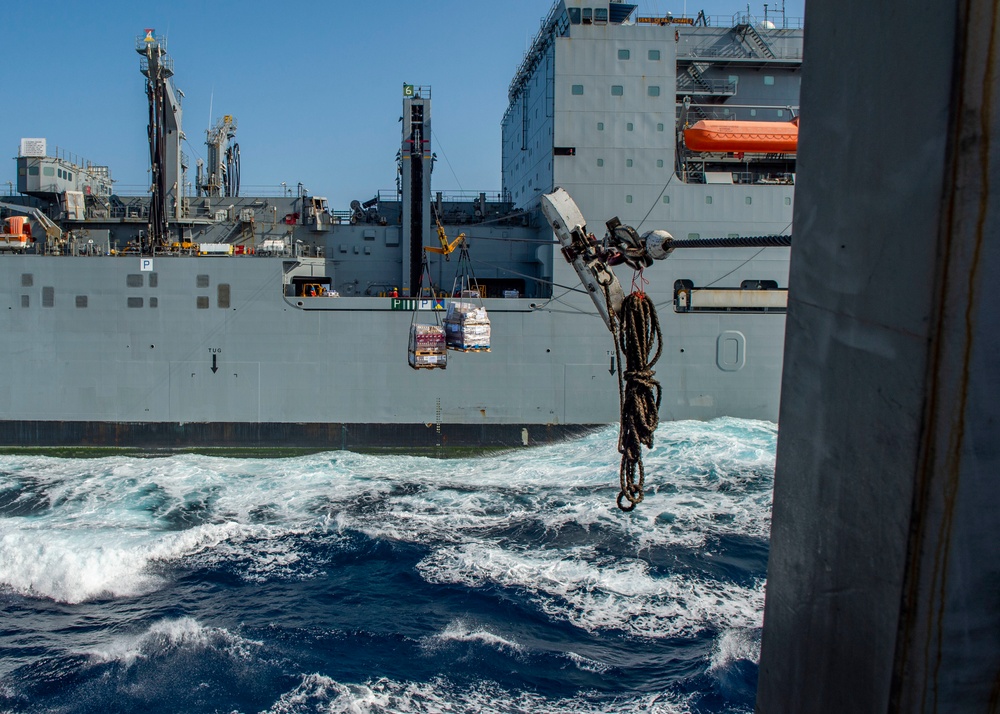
(757, 0), (1000, 714)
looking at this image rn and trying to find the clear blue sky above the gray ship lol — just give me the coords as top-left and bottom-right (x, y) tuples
(0, 0), (804, 209)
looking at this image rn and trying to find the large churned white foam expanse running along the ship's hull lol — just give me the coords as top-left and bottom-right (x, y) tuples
(0, 419), (776, 612)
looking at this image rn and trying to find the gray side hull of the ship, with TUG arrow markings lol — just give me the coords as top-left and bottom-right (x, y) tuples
(0, 249), (788, 448)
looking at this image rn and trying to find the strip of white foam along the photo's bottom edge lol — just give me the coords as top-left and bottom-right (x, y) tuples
(267, 674), (691, 714)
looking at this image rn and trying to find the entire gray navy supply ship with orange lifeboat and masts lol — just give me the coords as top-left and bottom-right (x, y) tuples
(0, 0), (808, 448)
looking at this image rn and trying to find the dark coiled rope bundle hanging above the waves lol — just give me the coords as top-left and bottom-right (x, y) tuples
(608, 291), (663, 512)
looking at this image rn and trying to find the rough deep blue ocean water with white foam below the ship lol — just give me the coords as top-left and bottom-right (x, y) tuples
(0, 419), (777, 713)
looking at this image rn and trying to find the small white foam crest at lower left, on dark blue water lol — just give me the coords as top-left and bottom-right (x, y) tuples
(79, 617), (263, 666)
